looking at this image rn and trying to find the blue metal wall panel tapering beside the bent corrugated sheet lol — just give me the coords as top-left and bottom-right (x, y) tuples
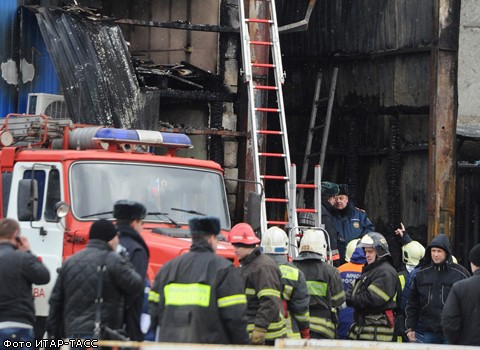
(18, 8), (62, 113)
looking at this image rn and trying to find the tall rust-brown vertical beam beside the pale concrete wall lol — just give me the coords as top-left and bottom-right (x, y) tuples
(428, 0), (460, 241)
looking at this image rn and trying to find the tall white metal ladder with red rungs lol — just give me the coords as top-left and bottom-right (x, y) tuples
(239, 0), (297, 233)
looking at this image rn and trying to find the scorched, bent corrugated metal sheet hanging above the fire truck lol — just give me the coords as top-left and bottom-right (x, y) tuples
(30, 7), (154, 127)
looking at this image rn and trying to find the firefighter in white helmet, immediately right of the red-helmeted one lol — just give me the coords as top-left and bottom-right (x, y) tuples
(261, 226), (310, 339)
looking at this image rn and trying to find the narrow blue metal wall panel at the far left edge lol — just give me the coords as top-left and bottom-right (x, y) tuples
(0, 0), (18, 117)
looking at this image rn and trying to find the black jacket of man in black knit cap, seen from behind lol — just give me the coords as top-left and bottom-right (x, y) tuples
(47, 239), (143, 338)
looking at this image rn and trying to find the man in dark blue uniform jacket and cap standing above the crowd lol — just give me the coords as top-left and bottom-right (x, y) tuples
(332, 184), (375, 264)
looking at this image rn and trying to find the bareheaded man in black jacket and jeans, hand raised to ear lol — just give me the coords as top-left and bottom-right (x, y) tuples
(0, 219), (50, 348)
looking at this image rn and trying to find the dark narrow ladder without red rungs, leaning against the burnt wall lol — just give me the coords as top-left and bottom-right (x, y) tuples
(296, 67), (338, 207)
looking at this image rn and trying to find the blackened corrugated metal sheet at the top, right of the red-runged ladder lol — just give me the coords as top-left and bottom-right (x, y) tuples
(277, 0), (431, 58)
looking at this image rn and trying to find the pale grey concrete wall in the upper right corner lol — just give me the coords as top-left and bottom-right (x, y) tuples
(458, 0), (480, 124)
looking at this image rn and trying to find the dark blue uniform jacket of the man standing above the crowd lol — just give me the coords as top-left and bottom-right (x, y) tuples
(332, 201), (375, 263)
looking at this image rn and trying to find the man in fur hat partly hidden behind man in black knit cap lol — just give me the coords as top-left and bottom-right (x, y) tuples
(113, 200), (149, 341)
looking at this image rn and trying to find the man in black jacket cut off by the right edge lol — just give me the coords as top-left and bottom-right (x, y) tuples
(442, 244), (480, 346)
